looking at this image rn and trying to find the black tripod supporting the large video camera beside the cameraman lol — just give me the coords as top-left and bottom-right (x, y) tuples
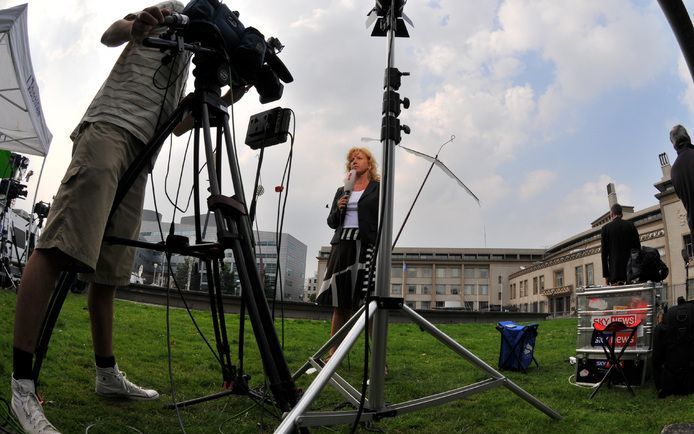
(34, 39), (298, 411)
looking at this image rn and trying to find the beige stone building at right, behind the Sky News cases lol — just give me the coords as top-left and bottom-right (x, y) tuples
(509, 153), (692, 316)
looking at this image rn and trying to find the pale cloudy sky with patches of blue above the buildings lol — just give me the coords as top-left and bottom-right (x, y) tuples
(0, 0), (694, 277)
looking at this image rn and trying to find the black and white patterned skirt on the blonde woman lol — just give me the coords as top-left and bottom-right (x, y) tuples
(316, 228), (374, 310)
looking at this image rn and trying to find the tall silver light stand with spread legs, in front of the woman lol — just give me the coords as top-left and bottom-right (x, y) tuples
(275, 0), (561, 434)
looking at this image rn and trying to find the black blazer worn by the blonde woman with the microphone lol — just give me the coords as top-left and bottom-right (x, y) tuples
(328, 181), (381, 244)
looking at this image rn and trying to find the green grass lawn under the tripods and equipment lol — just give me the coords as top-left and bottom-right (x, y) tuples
(0, 290), (694, 434)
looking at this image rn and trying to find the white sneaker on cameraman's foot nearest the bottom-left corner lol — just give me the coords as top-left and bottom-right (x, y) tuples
(12, 377), (60, 434)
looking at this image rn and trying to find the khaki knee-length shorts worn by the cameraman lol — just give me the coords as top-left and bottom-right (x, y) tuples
(36, 122), (147, 286)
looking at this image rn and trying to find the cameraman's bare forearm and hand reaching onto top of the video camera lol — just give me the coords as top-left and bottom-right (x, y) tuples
(101, 6), (171, 47)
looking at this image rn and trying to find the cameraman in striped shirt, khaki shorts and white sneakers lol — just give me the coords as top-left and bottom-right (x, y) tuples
(12, 1), (189, 434)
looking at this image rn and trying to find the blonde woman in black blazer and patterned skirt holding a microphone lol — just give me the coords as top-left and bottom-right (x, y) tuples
(316, 147), (380, 355)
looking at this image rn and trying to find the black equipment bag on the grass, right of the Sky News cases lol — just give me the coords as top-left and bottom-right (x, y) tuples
(653, 303), (694, 398)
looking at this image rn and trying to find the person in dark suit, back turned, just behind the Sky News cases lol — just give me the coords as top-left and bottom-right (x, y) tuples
(600, 203), (641, 285)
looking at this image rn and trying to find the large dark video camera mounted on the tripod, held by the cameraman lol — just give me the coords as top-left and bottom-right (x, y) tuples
(163, 0), (294, 104)
